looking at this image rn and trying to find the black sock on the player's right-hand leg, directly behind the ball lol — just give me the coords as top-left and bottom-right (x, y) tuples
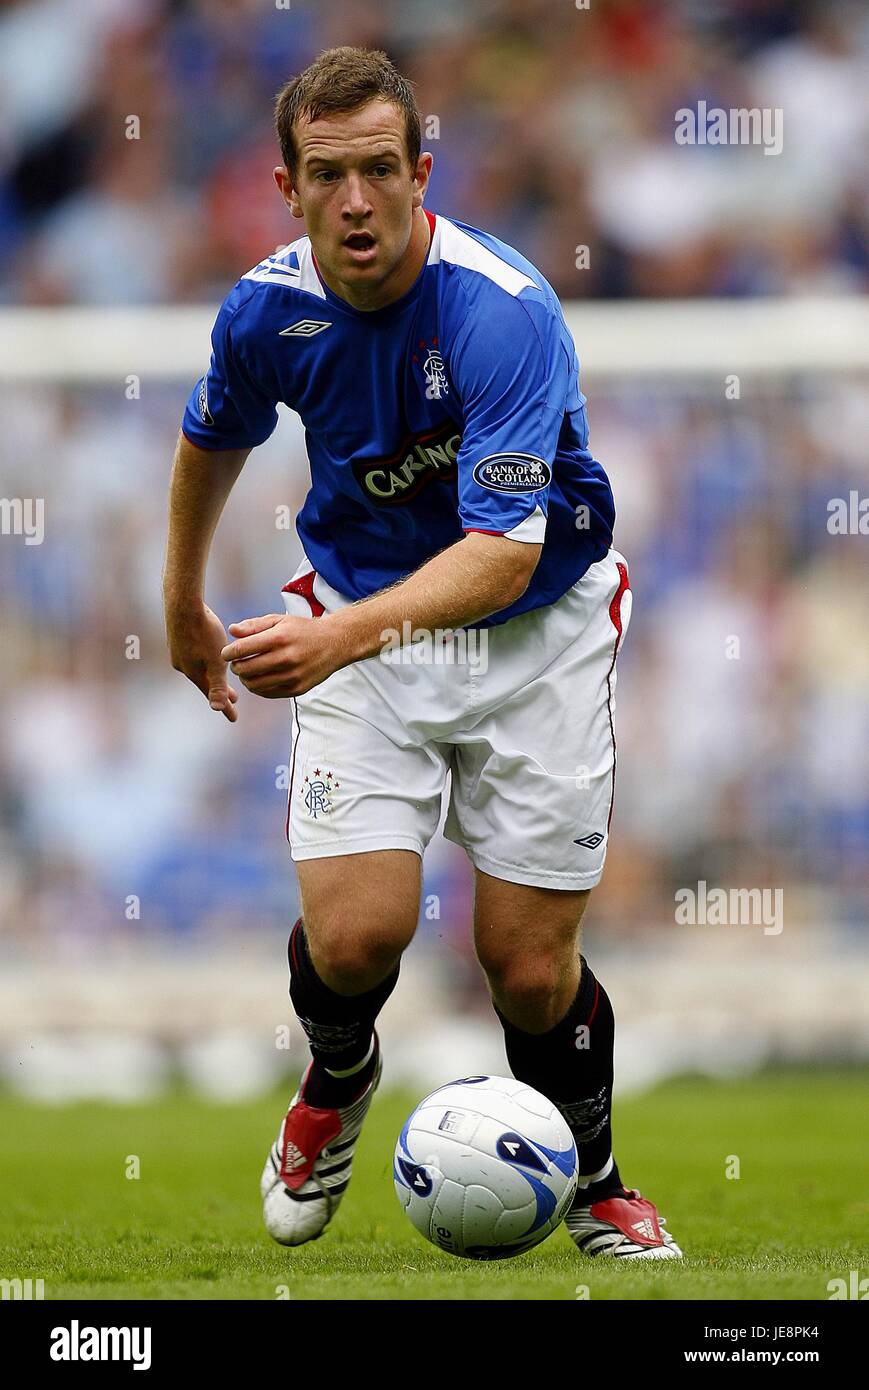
(495, 956), (622, 1201)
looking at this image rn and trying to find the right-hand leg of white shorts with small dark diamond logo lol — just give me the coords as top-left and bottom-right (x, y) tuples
(445, 552), (630, 892)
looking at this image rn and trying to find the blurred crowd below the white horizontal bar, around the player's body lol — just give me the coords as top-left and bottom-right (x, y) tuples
(0, 378), (869, 961)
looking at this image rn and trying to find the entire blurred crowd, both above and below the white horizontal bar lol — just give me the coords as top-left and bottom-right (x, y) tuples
(0, 0), (869, 978)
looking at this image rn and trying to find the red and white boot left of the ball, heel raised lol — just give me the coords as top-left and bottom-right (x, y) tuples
(260, 1033), (382, 1245)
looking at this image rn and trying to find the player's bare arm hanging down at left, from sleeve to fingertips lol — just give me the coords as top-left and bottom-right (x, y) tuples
(163, 435), (250, 721)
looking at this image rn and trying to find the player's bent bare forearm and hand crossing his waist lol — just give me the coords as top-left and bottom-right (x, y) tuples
(222, 531), (542, 699)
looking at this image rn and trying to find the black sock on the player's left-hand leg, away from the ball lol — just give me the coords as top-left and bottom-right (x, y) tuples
(286, 917), (399, 1108)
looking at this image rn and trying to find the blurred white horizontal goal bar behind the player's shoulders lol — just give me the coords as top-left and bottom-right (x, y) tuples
(0, 296), (869, 384)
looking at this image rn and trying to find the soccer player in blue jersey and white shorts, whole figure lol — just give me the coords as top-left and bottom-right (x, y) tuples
(164, 47), (681, 1259)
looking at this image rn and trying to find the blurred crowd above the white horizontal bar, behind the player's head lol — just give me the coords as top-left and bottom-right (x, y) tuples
(0, 0), (869, 303)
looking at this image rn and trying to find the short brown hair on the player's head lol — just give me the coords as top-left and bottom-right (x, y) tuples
(274, 47), (423, 174)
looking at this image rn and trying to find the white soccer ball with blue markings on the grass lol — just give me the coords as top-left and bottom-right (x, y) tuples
(392, 1076), (577, 1259)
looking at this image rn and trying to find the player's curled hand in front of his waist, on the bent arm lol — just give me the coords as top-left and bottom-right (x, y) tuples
(220, 613), (345, 699)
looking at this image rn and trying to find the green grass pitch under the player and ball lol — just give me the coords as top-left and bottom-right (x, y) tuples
(0, 1072), (869, 1300)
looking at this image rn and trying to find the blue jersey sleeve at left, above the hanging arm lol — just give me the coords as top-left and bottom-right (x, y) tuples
(181, 285), (278, 449)
